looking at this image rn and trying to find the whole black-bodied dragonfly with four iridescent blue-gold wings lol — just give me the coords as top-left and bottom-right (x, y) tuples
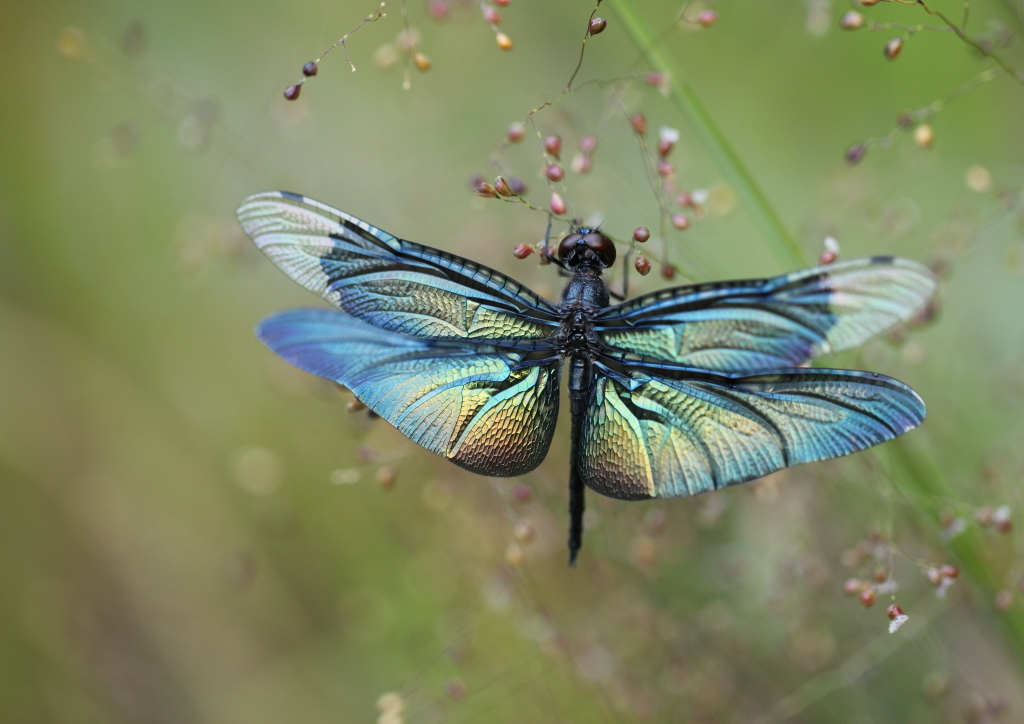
(238, 191), (935, 566)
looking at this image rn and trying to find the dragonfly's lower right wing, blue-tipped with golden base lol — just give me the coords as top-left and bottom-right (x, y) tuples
(574, 359), (925, 500)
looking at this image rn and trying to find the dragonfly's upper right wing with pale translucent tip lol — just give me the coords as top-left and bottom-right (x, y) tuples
(596, 257), (935, 372)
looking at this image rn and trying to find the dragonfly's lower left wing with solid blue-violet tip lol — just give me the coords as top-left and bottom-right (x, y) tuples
(256, 309), (558, 477)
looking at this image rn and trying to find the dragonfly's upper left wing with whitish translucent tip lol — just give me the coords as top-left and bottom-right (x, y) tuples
(238, 191), (558, 340)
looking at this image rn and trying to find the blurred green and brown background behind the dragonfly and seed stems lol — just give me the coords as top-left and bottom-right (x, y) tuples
(0, 0), (1024, 724)
